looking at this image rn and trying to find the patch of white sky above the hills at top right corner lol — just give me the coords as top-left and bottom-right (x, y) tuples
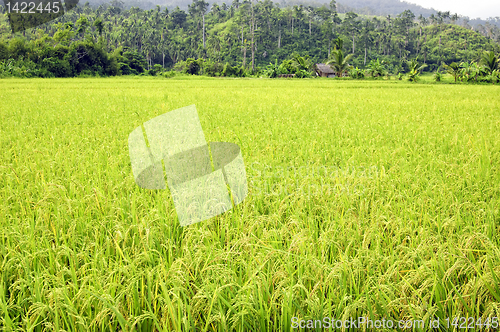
(406, 0), (500, 19)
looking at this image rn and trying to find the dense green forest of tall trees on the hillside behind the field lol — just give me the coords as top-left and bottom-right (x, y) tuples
(0, 0), (500, 77)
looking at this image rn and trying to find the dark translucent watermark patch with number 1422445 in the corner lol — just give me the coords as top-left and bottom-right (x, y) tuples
(3, 0), (79, 33)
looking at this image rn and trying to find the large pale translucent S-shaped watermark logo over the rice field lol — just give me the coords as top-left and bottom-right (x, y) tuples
(128, 105), (248, 226)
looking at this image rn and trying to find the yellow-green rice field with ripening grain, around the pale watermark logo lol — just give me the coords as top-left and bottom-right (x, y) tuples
(0, 77), (500, 331)
